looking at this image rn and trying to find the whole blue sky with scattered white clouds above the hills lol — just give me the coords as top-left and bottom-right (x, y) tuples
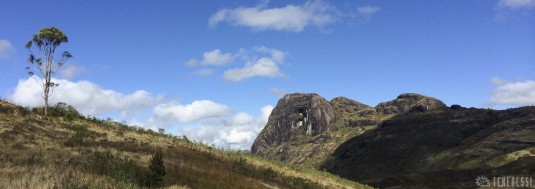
(0, 0), (535, 149)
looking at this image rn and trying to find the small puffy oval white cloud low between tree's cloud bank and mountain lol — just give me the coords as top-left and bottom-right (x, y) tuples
(154, 100), (230, 122)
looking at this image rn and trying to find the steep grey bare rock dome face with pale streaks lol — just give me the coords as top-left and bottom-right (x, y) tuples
(251, 94), (336, 157)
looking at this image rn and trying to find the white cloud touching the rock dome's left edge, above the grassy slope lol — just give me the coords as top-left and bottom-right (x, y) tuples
(182, 105), (273, 150)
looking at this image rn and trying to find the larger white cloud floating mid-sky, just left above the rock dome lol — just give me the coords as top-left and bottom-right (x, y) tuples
(223, 47), (286, 81)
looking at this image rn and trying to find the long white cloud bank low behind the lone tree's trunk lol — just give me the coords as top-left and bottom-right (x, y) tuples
(10, 76), (162, 118)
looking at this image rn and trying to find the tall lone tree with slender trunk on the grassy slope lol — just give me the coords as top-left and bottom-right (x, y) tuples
(26, 27), (72, 116)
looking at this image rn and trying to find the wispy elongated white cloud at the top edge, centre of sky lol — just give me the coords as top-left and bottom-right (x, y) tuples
(208, 0), (336, 32)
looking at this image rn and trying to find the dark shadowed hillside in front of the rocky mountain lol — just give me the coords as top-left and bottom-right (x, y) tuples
(321, 107), (535, 188)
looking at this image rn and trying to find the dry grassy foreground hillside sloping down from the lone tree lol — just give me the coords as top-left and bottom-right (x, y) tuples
(0, 101), (368, 188)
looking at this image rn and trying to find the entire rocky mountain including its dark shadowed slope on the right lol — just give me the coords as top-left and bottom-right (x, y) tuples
(252, 93), (535, 188)
